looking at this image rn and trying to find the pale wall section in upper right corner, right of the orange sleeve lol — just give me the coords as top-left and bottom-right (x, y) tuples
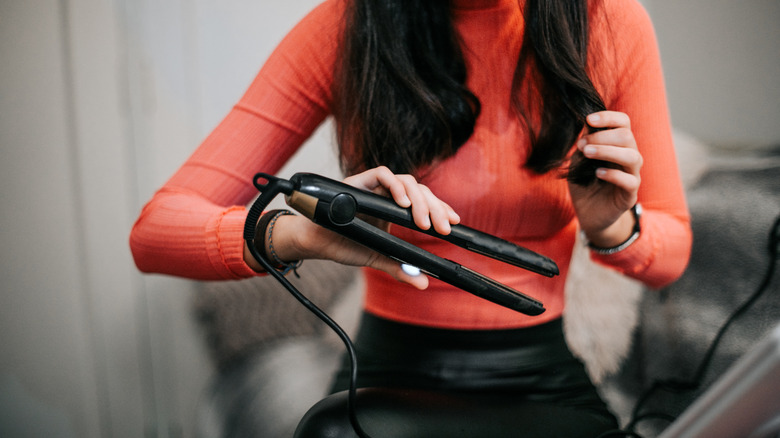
(643, 0), (780, 148)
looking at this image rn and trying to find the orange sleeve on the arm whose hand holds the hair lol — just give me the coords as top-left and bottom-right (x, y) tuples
(592, 0), (692, 288)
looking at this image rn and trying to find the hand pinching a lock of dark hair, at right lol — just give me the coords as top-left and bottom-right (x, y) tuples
(569, 111), (642, 248)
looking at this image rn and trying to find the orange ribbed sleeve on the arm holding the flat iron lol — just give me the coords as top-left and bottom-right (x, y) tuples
(130, 1), (341, 280)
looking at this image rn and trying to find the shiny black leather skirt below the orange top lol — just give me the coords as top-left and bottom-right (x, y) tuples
(320, 314), (618, 438)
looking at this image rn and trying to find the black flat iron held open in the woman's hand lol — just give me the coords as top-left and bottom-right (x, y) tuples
(244, 173), (559, 316)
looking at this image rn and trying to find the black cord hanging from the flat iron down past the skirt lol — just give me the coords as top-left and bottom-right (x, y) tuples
(246, 240), (371, 438)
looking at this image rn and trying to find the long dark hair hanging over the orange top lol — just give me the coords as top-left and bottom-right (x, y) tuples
(334, 0), (604, 183)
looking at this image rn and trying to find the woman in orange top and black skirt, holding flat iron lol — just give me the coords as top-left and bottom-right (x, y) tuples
(131, 0), (691, 436)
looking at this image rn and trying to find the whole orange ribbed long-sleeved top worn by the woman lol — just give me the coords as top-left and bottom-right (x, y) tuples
(131, 0), (691, 329)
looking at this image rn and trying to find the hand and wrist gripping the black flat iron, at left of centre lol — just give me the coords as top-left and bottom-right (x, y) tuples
(244, 167), (460, 289)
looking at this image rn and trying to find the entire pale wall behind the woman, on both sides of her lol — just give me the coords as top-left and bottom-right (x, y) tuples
(0, 0), (780, 437)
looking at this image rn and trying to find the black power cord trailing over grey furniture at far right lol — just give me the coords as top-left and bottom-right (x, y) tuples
(597, 210), (780, 438)
